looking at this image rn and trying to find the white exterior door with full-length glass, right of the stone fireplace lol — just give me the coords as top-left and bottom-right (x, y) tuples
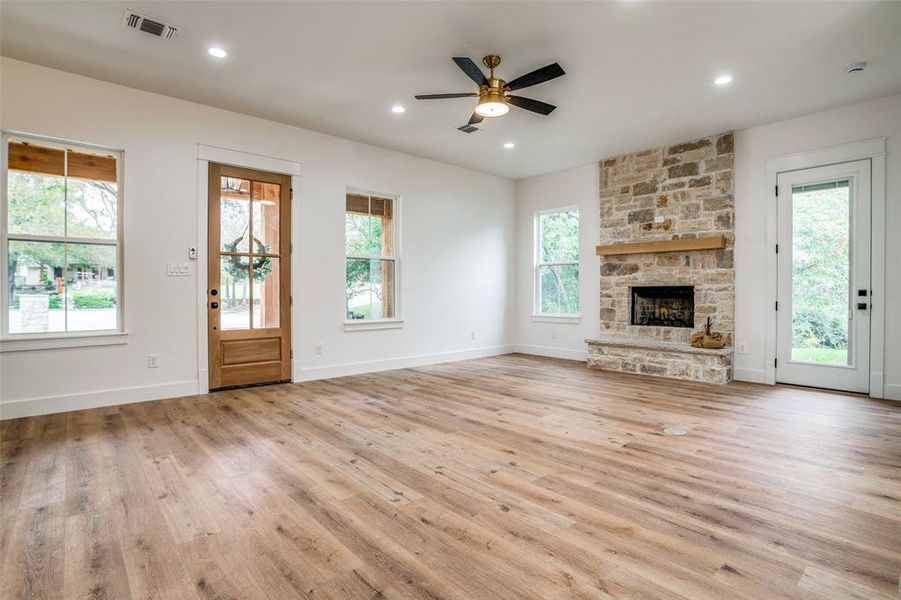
(776, 160), (871, 393)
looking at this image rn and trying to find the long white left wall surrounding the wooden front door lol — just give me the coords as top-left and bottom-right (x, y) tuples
(0, 58), (516, 418)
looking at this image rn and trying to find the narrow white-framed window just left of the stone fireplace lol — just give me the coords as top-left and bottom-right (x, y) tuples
(535, 208), (579, 317)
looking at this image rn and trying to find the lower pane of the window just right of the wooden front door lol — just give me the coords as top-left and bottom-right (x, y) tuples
(346, 258), (394, 320)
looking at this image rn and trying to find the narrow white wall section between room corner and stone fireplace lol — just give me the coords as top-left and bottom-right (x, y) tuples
(516, 163), (601, 360)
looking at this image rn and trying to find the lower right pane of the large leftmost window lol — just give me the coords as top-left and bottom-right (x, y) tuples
(66, 244), (118, 331)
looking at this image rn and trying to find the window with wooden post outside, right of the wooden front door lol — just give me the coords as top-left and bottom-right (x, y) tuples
(344, 192), (398, 323)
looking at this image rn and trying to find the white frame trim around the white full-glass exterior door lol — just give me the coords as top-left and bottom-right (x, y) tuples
(764, 137), (886, 398)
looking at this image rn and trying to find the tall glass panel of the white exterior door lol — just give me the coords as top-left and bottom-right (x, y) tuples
(792, 179), (852, 365)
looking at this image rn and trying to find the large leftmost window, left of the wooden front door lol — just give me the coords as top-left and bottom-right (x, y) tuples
(0, 134), (122, 337)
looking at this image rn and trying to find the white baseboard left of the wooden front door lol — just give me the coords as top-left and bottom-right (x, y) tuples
(0, 381), (197, 420)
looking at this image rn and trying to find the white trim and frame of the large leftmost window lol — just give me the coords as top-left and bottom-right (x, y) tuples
(0, 129), (128, 352)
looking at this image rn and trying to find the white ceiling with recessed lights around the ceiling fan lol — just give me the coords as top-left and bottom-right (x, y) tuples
(0, 0), (901, 178)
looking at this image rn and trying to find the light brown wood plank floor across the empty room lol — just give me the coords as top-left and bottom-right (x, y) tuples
(0, 355), (901, 599)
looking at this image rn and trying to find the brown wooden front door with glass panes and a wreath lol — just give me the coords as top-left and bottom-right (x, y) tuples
(207, 163), (291, 389)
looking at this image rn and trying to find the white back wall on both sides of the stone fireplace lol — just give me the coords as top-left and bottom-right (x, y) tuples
(516, 95), (901, 399)
